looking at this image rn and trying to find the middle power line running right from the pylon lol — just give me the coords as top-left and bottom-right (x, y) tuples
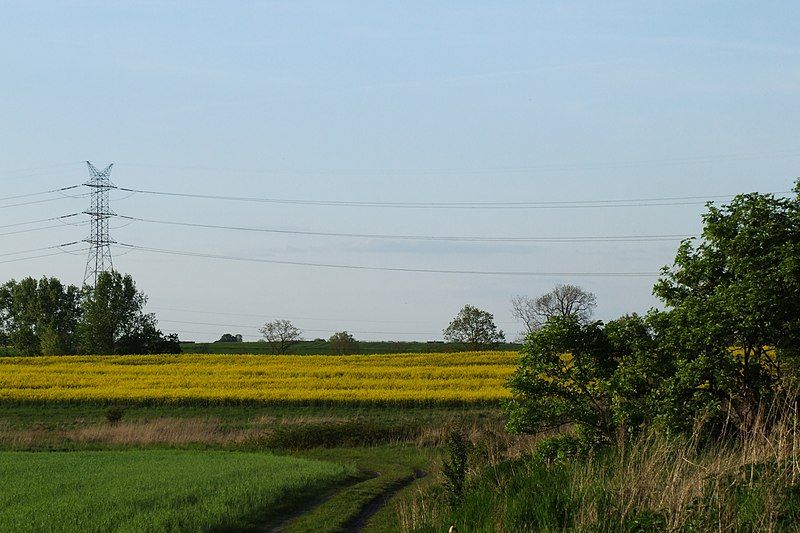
(117, 215), (697, 243)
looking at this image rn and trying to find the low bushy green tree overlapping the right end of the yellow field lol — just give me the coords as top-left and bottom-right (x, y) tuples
(505, 313), (675, 444)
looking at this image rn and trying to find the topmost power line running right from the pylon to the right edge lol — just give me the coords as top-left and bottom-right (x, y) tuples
(118, 187), (791, 209)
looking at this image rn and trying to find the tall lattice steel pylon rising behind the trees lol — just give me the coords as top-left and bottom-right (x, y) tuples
(83, 161), (116, 287)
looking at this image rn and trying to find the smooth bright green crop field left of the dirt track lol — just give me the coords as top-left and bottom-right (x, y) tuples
(0, 450), (358, 532)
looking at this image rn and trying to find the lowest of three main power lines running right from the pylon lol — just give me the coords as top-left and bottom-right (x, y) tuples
(117, 243), (659, 277)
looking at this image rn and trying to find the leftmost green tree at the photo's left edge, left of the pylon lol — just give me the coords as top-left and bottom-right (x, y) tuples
(0, 277), (81, 355)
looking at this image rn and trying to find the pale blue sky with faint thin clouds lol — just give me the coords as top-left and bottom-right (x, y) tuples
(0, 0), (800, 341)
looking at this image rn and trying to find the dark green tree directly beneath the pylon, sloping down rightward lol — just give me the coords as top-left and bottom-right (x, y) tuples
(78, 271), (180, 354)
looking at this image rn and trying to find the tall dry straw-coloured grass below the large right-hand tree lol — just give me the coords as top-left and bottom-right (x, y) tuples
(572, 398), (800, 531)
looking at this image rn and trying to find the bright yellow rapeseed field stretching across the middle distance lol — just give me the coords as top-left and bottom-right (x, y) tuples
(0, 352), (518, 405)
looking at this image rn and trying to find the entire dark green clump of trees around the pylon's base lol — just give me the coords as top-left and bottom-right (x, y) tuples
(0, 271), (180, 355)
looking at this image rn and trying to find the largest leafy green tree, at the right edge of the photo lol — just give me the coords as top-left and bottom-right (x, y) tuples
(654, 185), (800, 429)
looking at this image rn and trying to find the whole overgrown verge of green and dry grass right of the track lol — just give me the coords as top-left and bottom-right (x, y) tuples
(396, 396), (800, 532)
